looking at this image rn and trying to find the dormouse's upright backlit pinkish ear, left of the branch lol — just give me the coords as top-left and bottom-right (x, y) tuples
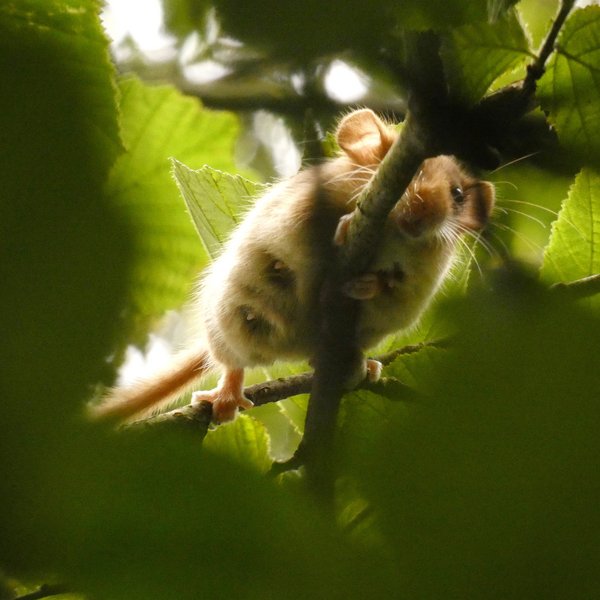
(336, 108), (396, 165)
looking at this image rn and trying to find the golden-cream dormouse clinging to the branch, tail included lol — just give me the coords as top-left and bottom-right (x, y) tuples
(92, 109), (494, 422)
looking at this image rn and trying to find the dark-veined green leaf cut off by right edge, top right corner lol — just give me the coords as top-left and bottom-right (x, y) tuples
(538, 6), (600, 164)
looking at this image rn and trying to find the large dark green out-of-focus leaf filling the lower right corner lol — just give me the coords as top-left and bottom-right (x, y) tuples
(351, 278), (600, 599)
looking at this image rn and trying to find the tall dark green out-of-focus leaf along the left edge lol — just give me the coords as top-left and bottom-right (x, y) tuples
(0, 0), (131, 571)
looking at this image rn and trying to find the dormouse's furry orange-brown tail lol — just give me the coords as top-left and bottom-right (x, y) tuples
(89, 351), (211, 420)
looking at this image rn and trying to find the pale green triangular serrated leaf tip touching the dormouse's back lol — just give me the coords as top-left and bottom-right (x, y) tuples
(172, 160), (257, 258)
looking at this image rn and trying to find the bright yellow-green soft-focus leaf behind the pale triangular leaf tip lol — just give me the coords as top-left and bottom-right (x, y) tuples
(108, 79), (238, 335)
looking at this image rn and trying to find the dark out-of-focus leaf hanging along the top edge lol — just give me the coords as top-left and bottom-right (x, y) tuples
(215, 0), (515, 63)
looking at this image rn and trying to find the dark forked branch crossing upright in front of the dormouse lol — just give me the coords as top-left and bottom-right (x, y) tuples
(292, 0), (573, 496)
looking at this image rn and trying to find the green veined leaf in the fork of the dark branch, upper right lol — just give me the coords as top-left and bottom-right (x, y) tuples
(442, 11), (533, 104)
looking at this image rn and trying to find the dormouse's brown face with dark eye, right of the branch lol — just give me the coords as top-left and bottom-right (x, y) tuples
(390, 156), (495, 240)
